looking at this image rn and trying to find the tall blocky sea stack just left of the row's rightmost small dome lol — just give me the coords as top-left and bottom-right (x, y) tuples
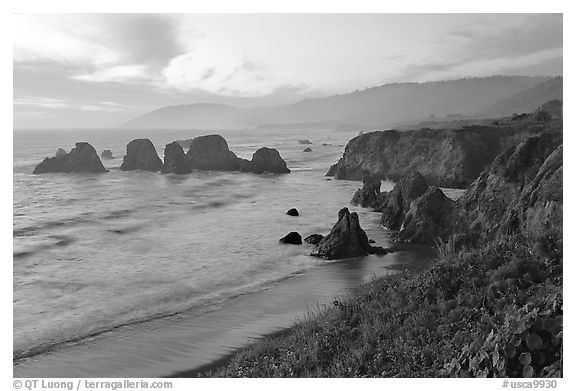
(187, 134), (240, 171)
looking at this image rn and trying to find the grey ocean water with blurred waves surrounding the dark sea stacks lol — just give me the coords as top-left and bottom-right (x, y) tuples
(13, 129), (446, 377)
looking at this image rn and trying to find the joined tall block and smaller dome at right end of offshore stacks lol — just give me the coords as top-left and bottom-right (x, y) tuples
(187, 134), (290, 174)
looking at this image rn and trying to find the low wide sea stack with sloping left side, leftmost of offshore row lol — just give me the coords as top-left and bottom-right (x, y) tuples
(33, 142), (108, 174)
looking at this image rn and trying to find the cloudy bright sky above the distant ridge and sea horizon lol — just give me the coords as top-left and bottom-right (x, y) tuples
(12, 14), (562, 128)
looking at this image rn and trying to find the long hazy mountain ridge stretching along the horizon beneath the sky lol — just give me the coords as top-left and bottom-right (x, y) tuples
(120, 76), (562, 129)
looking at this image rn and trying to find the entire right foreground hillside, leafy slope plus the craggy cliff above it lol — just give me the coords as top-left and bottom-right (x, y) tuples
(210, 112), (563, 377)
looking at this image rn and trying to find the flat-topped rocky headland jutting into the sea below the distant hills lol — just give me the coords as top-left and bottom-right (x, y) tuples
(326, 115), (561, 188)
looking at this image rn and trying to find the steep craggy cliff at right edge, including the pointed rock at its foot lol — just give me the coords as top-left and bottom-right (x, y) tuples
(397, 133), (562, 248)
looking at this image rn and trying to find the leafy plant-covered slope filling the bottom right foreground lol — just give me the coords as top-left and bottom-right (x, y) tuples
(212, 236), (562, 377)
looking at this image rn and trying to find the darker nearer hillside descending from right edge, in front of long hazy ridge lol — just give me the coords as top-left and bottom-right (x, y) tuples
(479, 77), (563, 118)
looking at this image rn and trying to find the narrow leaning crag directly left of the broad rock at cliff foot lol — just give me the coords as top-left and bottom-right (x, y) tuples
(380, 171), (428, 229)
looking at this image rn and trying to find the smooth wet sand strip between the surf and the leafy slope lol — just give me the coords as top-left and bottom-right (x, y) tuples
(13, 231), (431, 377)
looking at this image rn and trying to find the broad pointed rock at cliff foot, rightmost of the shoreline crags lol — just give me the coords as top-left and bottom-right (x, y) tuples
(397, 187), (456, 245)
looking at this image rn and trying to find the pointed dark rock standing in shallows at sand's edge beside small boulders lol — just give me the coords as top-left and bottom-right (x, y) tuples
(311, 208), (386, 259)
